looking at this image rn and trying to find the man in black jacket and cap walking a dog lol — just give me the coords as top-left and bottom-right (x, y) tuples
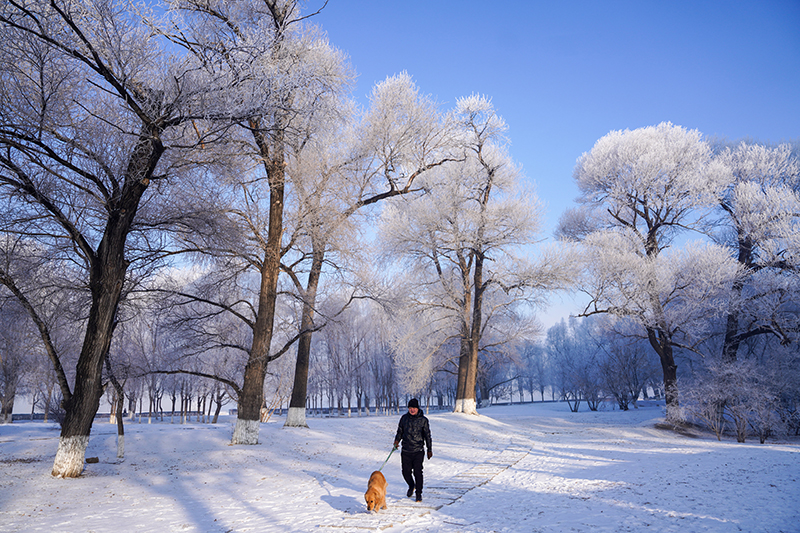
(394, 398), (433, 502)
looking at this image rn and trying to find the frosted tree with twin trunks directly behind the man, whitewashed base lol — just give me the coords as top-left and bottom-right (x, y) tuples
(381, 95), (567, 413)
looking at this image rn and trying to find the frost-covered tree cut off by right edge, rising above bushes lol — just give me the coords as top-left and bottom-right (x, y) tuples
(716, 142), (800, 363)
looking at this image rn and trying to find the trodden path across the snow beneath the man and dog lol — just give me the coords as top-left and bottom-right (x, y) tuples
(319, 444), (530, 532)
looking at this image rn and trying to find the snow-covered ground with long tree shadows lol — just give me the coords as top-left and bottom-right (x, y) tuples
(0, 403), (800, 533)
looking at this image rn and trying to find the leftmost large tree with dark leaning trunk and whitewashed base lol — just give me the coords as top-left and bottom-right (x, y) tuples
(0, 0), (212, 477)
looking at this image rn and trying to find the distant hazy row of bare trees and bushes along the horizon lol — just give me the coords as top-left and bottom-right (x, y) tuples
(7, 270), (800, 441)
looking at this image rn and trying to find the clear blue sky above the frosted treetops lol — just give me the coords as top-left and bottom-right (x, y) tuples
(307, 0), (800, 320)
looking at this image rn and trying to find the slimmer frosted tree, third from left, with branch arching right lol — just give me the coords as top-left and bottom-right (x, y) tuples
(284, 73), (460, 427)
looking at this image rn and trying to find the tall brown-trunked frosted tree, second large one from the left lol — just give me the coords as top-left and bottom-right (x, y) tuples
(148, 0), (349, 444)
